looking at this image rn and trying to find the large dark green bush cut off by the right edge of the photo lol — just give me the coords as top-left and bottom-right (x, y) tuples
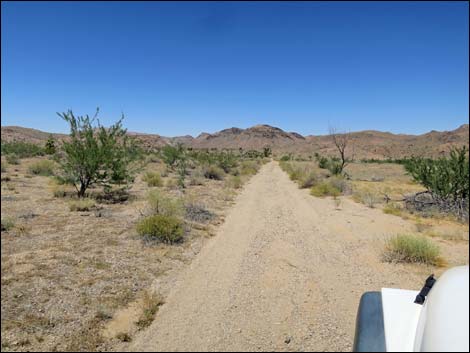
(405, 146), (470, 216)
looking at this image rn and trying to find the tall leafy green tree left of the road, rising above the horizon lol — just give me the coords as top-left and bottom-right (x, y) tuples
(57, 109), (141, 197)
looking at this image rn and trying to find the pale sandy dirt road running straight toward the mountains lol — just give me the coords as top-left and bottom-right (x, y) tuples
(130, 162), (432, 351)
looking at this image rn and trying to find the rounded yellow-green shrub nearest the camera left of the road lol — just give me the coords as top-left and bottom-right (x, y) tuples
(137, 214), (184, 244)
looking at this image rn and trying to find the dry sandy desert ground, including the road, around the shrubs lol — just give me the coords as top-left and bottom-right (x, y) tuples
(1, 153), (468, 351)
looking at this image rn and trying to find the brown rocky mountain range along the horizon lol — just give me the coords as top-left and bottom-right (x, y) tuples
(1, 124), (469, 159)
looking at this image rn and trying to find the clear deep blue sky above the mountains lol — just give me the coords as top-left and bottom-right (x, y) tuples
(1, 2), (469, 136)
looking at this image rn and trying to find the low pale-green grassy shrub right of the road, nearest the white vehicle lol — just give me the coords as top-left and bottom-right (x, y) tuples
(383, 234), (444, 266)
